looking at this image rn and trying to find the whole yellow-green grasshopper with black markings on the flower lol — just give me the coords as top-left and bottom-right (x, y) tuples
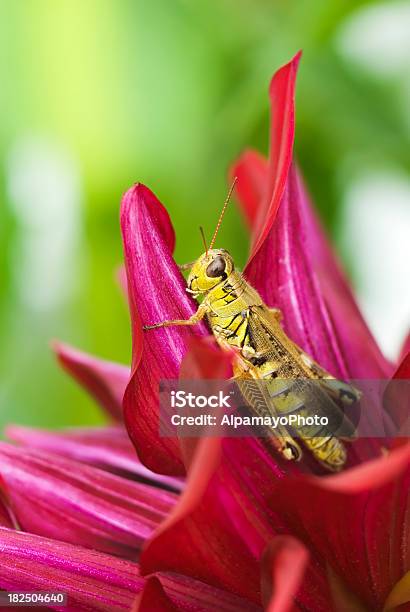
(144, 181), (360, 472)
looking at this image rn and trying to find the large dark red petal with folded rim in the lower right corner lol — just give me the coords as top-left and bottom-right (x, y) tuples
(271, 445), (410, 610)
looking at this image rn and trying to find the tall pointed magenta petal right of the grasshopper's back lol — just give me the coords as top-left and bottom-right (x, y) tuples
(234, 156), (391, 462)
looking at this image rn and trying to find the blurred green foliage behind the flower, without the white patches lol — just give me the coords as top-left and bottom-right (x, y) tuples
(0, 0), (410, 425)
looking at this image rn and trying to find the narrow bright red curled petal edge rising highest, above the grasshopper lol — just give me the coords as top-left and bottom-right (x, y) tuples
(249, 51), (302, 261)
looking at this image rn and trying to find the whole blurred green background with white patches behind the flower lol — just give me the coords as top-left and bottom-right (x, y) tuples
(0, 0), (410, 426)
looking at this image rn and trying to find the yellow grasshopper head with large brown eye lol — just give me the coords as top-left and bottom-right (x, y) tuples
(187, 249), (234, 296)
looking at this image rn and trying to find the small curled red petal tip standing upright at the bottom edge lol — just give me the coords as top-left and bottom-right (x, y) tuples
(262, 536), (309, 612)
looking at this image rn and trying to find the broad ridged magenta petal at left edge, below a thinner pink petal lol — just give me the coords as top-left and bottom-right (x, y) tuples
(0, 443), (176, 558)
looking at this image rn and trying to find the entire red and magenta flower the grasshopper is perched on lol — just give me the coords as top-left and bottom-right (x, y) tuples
(0, 55), (410, 612)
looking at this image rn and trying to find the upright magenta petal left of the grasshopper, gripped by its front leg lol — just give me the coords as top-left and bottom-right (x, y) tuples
(121, 184), (206, 475)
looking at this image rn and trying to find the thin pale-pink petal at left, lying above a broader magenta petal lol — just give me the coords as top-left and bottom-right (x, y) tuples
(6, 425), (183, 491)
